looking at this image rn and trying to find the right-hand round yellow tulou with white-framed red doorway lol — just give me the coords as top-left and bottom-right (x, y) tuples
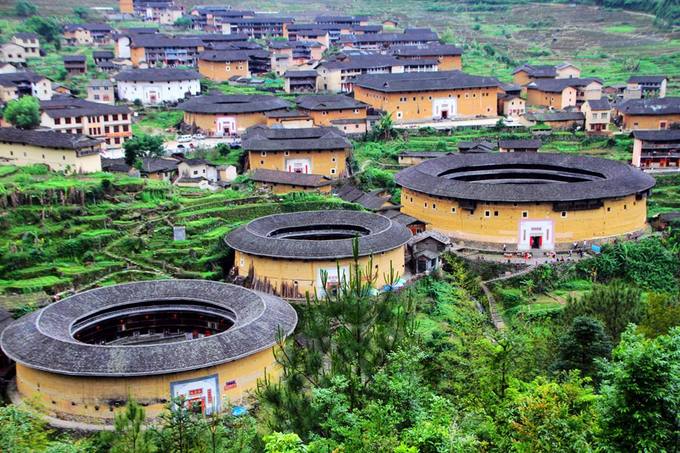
(395, 152), (654, 250)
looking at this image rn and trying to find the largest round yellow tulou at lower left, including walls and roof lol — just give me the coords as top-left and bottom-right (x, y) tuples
(0, 280), (297, 422)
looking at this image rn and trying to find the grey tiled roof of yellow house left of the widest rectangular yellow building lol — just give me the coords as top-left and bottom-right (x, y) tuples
(177, 94), (288, 113)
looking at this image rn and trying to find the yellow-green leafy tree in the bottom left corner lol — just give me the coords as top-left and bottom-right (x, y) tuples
(0, 404), (49, 453)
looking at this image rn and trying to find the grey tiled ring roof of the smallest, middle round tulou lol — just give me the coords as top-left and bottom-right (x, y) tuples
(225, 210), (411, 260)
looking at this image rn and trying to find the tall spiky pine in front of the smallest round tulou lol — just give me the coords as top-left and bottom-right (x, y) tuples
(256, 241), (415, 438)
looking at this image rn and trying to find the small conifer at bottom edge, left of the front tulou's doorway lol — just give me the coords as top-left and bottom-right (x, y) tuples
(111, 400), (156, 453)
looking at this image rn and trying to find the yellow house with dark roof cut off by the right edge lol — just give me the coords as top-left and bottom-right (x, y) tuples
(617, 97), (680, 131)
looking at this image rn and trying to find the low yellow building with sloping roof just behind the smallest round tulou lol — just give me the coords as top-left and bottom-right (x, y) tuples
(249, 168), (334, 195)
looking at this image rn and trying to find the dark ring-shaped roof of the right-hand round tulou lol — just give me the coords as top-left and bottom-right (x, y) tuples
(395, 153), (654, 202)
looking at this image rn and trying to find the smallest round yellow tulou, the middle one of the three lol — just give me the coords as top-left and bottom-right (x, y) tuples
(225, 210), (411, 298)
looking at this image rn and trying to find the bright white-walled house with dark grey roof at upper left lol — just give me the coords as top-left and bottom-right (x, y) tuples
(115, 68), (201, 105)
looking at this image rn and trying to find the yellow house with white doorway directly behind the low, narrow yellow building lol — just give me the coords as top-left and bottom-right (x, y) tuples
(243, 126), (352, 179)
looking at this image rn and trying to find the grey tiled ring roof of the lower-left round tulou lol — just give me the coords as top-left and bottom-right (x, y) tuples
(0, 280), (297, 377)
